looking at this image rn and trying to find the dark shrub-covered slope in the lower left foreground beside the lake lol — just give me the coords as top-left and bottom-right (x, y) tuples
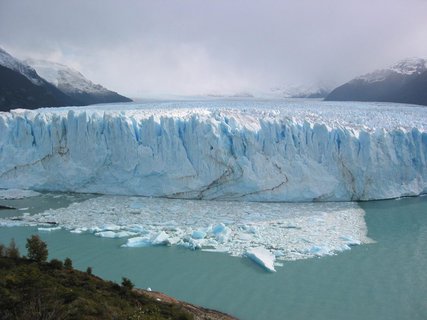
(0, 255), (236, 320)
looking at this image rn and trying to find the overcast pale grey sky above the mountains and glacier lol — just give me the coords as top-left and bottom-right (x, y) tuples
(0, 0), (427, 97)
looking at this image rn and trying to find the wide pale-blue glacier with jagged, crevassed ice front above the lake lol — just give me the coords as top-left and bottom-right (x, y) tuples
(0, 102), (427, 201)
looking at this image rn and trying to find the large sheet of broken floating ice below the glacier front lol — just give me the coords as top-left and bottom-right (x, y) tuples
(0, 195), (371, 271)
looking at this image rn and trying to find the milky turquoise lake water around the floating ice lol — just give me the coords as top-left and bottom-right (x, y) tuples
(0, 196), (427, 320)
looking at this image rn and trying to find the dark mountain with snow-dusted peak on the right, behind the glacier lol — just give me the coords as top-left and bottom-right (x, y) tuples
(326, 58), (427, 105)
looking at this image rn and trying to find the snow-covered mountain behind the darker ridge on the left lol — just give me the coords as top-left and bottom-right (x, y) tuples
(26, 59), (132, 104)
